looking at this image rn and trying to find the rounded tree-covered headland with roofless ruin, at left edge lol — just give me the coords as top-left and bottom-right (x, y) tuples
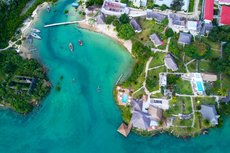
(0, 50), (50, 113)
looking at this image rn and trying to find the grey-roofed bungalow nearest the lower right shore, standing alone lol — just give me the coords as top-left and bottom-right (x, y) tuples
(200, 105), (220, 126)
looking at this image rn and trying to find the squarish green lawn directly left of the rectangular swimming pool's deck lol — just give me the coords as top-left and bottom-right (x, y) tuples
(175, 79), (193, 95)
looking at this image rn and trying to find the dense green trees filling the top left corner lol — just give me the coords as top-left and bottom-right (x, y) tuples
(0, 0), (57, 48)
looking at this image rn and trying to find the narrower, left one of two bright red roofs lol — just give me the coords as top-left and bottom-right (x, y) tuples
(204, 0), (214, 20)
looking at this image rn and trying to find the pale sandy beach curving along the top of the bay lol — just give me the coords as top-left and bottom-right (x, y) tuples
(78, 20), (132, 55)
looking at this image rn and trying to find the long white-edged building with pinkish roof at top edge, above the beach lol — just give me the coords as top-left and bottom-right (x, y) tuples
(101, 0), (129, 17)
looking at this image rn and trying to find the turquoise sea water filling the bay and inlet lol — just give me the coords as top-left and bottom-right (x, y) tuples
(0, 0), (230, 153)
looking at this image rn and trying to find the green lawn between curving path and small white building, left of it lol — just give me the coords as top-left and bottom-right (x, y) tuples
(146, 67), (166, 92)
